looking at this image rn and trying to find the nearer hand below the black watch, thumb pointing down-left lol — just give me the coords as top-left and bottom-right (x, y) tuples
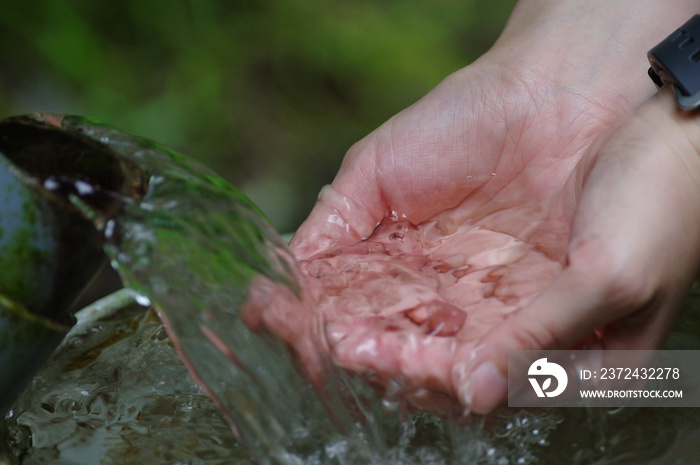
(464, 85), (700, 412)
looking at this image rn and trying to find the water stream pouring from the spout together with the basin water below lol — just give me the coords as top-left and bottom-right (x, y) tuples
(0, 116), (700, 465)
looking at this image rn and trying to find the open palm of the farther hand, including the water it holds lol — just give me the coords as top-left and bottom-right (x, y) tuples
(293, 67), (611, 408)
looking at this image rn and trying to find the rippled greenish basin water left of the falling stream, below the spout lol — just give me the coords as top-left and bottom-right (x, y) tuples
(0, 293), (242, 465)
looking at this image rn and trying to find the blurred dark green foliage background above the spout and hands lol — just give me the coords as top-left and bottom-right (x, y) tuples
(0, 0), (515, 231)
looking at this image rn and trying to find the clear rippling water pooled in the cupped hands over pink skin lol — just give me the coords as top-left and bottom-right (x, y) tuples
(301, 212), (562, 410)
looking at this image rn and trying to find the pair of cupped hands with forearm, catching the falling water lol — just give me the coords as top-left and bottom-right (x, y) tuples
(259, 0), (700, 412)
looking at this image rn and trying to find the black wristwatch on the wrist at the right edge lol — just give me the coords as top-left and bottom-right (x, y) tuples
(647, 15), (700, 110)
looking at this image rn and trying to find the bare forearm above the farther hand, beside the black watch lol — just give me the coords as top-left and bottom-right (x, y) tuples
(487, 0), (700, 114)
